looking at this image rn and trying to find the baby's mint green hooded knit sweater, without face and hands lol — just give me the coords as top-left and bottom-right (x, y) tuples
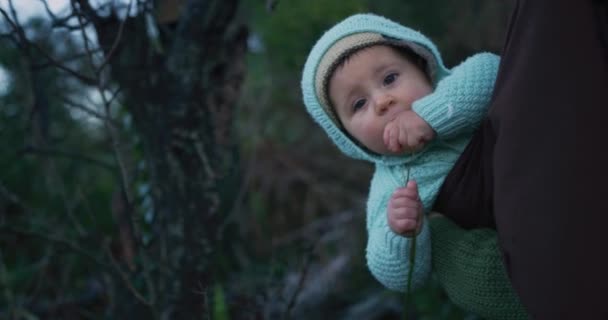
(301, 14), (499, 291)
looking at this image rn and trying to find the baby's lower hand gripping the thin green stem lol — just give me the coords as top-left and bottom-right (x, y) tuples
(387, 181), (423, 237)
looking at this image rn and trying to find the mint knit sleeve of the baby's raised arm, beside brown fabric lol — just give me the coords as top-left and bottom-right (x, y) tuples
(412, 53), (500, 139)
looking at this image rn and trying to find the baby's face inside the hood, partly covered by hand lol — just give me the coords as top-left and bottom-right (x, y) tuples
(329, 45), (433, 155)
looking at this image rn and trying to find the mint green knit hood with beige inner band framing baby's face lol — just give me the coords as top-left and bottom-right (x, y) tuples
(301, 14), (449, 164)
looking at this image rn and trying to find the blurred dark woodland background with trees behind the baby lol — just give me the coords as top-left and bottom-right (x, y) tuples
(0, 0), (511, 320)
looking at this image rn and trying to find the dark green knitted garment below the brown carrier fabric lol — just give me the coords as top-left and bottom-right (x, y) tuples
(428, 217), (528, 320)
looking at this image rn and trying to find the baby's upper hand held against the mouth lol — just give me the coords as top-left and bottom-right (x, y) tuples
(383, 110), (435, 153)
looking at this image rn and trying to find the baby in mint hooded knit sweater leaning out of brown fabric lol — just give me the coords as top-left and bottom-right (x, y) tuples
(302, 14), (499, 291)
